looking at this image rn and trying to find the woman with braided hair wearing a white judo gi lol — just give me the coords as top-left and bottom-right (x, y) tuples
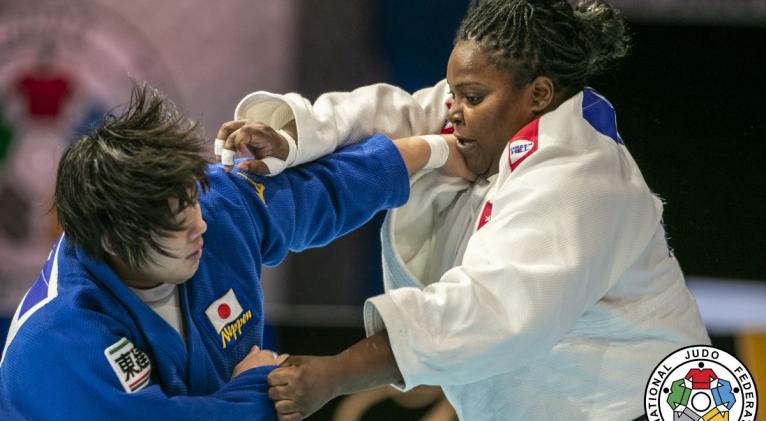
(224, 0), (709, 421)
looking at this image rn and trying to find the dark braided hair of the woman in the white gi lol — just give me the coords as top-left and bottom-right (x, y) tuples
(455, 0), (630, 95)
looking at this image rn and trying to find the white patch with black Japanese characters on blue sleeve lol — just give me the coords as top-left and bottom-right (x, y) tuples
(104, 338), (152, 393)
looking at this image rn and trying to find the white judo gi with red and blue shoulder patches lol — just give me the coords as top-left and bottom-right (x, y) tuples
(236, 81), (709, 420)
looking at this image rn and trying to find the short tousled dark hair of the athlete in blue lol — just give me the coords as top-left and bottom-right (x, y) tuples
(53, 83), (207, 267)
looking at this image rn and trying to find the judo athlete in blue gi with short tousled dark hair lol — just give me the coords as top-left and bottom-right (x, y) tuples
(0, 86), (468, 420)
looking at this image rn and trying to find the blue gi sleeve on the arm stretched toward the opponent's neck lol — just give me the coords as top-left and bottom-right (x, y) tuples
(246, 135), (409, 265)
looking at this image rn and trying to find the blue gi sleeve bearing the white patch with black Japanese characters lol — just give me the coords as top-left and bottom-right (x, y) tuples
(0, 312), (276, 420)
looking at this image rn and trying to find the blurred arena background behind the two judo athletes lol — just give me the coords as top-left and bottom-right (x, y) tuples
(0, 0), (766, 420)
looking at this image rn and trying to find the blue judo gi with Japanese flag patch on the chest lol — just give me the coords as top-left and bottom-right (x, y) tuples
(0, 135), (409, 420)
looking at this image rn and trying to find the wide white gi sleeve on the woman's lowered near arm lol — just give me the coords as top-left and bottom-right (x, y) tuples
(365, 138), (661, 389)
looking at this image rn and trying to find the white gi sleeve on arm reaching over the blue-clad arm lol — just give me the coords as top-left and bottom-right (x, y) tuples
(234, 80), (450, 169)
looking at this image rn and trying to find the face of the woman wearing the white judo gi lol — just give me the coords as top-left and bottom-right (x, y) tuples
(447, 41), (535, 177)
